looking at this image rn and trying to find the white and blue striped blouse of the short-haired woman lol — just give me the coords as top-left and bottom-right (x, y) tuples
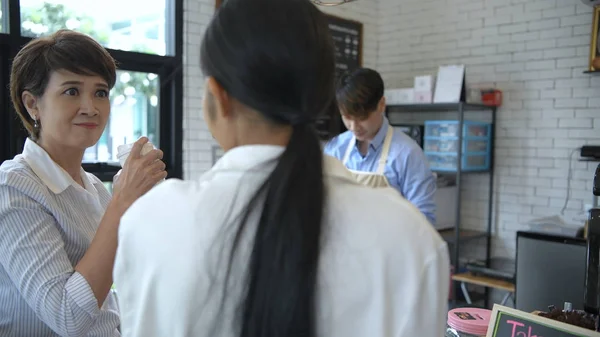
(0, 140), (120, 337)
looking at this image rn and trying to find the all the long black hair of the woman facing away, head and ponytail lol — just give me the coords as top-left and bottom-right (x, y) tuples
(201, 0), (335, 337)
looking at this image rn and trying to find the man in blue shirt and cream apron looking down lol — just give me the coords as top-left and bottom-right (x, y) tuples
(324, 68), (436, 224)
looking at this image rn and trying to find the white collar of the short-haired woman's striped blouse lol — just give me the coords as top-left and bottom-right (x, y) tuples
(22, 138), (96, 194)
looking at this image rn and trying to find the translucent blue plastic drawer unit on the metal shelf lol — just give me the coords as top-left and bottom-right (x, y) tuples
(423, 120), (492, 172)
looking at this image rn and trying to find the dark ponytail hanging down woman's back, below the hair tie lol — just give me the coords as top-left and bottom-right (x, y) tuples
(240, 125), (324, 337)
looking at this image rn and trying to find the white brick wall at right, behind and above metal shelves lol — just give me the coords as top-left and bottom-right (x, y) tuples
(377, 0), (600, 256)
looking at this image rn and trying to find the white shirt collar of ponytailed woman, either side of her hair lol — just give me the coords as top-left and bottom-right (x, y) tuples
(211, 145), (358, 184)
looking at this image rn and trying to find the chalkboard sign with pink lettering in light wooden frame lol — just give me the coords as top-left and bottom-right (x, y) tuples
(486, 304), (600, 337)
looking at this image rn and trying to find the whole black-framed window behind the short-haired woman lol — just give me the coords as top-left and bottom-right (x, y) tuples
(0, 0), (183, 189)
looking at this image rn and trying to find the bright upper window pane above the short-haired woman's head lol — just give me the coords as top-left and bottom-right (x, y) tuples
(19, 0), (174, 55)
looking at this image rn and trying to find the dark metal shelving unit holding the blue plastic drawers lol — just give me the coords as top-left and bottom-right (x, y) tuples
(386, 103), (496, 304)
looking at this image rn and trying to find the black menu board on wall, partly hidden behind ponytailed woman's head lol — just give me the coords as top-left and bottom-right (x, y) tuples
(317, 15), (363, 140)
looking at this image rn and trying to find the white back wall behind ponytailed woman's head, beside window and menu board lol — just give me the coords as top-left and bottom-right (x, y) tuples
(183, 0), (378, 179)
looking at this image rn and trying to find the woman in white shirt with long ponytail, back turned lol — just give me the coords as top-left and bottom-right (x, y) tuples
(114, 0), (449, 337)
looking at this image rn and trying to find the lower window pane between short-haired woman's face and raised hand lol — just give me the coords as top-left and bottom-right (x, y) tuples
(83, 70), (160, 163)
